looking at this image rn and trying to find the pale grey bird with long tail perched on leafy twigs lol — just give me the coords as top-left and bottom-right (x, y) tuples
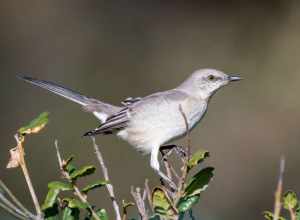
(20, 69), (241, 187)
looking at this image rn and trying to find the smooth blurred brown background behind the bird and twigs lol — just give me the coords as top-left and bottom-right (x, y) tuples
(0, 0), (300, 220)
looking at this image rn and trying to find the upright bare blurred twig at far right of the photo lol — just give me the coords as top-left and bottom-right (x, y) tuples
(274, 157), (285, 220)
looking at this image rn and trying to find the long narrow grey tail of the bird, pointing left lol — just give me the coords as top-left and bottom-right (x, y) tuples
(18, 75), (121, 122)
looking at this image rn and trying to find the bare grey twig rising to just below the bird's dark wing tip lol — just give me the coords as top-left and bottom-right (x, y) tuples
(91, 136), (121, 220)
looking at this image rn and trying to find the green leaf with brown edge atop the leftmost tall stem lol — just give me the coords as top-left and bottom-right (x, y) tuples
(18, 112), (49, 135)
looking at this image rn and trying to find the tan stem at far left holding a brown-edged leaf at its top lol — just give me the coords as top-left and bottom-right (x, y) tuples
(15, 134), (42, 219)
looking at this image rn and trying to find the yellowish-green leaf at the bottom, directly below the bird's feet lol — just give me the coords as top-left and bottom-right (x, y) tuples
(152, 187), (176, 217)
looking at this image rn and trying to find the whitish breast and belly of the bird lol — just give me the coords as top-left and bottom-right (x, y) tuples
(118, 97), (206, 153)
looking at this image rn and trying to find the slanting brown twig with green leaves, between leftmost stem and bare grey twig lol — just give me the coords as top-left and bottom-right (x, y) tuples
(55, 140), (100, 220)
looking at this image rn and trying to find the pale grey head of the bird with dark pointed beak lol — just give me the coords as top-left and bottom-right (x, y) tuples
(179, 69), (241, 99)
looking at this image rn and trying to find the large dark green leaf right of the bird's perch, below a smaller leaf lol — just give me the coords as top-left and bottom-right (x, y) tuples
(185, 167), (214, 196)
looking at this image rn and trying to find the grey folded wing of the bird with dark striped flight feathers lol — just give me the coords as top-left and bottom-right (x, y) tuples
(84, 90), (187, 136)
